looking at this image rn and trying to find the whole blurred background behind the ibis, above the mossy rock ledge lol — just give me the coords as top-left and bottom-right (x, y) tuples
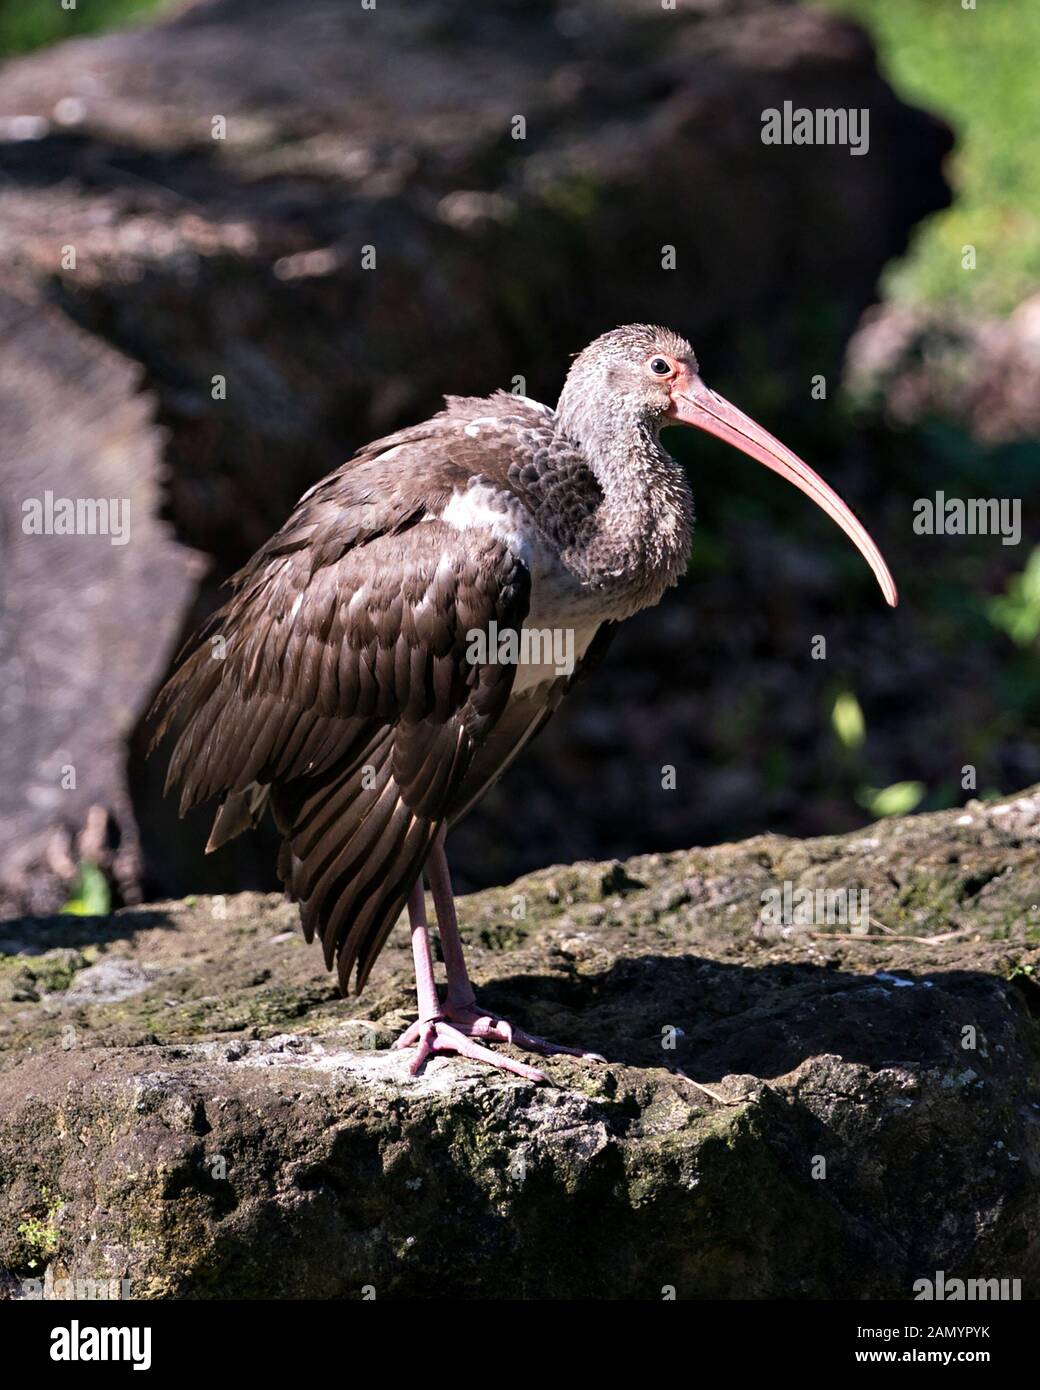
(0, 0), (1040, 913)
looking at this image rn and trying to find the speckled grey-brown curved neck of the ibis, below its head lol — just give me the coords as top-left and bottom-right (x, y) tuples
(559, 405), (694, 612)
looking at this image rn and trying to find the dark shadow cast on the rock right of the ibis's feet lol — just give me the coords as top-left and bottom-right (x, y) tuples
(464, 955), (1040, 1084)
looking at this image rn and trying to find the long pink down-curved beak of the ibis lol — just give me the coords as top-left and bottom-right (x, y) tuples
(667, 375), (898, 607)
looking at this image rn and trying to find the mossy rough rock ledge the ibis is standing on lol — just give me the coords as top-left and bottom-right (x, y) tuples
(0, 788), (1040, 1300)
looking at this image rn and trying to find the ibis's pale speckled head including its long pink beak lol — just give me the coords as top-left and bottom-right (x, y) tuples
(559, 324), (898, 607)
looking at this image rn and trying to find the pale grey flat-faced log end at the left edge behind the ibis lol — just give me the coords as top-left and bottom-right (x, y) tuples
(0, 289), (204, 916)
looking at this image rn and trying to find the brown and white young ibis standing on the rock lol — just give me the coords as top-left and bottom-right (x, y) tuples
(153, 324), (897, 1083)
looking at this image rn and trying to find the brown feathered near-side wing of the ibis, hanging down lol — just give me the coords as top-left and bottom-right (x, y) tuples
(156, 439), (530, 990)
